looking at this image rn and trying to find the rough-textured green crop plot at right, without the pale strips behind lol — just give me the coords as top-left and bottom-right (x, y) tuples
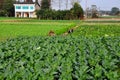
(72, 23), (120, 37)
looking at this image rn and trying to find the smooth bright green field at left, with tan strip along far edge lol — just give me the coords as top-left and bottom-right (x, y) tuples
(0, 18), (75, 40)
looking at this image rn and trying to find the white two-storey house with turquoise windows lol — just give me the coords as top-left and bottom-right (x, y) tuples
(14, 0), (40, 18)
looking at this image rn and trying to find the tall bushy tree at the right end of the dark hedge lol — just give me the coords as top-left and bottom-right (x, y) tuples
(71, 2), (84, 19)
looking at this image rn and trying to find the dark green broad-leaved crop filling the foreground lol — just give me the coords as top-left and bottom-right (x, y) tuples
(0, 36), (120, 80)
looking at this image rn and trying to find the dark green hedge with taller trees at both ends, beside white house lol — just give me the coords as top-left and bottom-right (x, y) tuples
(36, 0), (84, 20)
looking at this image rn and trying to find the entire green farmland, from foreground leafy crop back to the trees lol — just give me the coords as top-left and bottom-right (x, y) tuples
(0, 18), (120, 80)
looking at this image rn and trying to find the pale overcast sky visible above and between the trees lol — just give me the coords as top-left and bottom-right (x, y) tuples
(52, 0), (120, 10)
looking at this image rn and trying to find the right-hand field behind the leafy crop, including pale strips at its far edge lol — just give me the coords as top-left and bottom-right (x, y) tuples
(73, 19), (120, 37)
